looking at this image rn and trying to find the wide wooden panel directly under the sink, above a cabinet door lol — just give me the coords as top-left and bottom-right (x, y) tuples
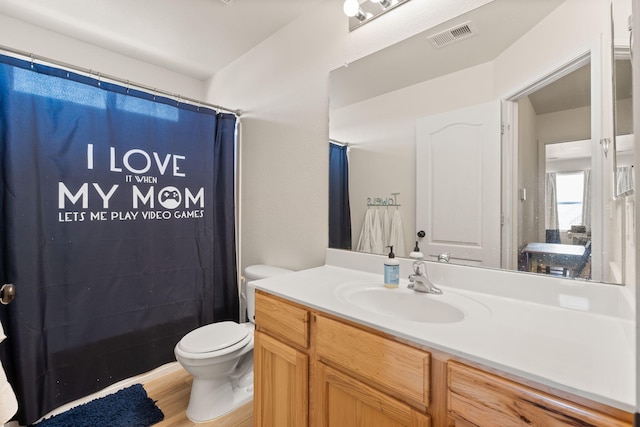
(316, 316), (430, 406)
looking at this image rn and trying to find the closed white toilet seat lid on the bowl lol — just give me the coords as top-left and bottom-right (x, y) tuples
(177, 321), (253, 357)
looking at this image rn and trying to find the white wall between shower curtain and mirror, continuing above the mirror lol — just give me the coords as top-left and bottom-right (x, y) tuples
(202, 0), (488, 269)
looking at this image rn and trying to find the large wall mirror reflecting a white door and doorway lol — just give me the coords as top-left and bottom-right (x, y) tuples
(329, 0), (635, 284)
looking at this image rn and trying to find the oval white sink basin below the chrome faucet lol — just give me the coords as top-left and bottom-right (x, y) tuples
(336, 281), (490, 323)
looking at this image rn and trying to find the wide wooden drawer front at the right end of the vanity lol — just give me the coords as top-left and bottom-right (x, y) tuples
(447, 361), (631, 427)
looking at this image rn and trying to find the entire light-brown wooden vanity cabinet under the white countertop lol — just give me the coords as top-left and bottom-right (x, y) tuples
(254, 291), (633, 427)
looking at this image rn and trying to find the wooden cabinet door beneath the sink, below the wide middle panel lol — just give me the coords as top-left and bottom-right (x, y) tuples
(318, 363), (431, 427)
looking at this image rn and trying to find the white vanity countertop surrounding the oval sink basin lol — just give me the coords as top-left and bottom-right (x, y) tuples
(250, 264), (635, 412)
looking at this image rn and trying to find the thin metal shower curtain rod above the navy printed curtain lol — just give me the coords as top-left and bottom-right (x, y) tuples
(0, 45), (242, 117)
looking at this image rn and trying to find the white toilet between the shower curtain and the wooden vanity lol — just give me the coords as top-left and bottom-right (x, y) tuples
(174, 265), (291, 423)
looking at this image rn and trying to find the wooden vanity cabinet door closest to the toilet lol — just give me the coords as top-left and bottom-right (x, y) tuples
(253, 331), (309, 427)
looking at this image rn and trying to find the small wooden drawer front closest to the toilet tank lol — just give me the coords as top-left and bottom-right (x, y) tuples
(256, 292), (309, 348)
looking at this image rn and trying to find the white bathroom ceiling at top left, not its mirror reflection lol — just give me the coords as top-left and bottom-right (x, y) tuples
(0, 0), (320, 80)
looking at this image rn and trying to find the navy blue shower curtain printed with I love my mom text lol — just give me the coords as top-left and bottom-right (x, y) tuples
(0, 56), (238, 424)
